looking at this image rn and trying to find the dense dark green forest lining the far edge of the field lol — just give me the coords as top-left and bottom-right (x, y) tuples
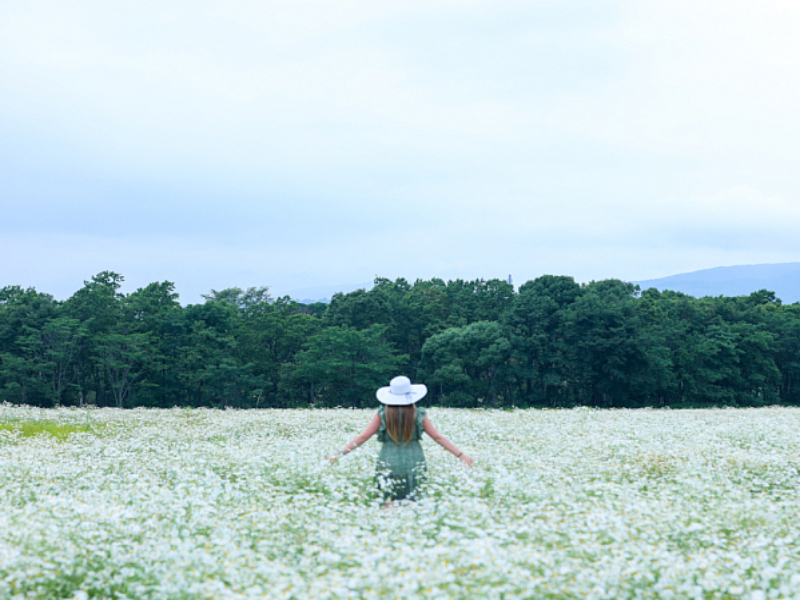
(0, 271), (800, 408)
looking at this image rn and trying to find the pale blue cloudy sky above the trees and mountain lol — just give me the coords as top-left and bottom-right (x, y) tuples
(0, 0), (800, 303)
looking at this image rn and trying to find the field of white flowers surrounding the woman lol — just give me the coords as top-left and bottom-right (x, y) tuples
(0, 405), (800, 600)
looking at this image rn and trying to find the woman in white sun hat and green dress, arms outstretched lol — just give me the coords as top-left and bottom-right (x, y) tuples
(327, 376), (474, 500)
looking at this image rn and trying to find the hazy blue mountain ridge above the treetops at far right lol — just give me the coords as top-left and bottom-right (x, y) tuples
(632, 262), (800, 304)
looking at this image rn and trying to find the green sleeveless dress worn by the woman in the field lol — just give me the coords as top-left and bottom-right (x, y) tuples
(375, 404), (425, 500)
